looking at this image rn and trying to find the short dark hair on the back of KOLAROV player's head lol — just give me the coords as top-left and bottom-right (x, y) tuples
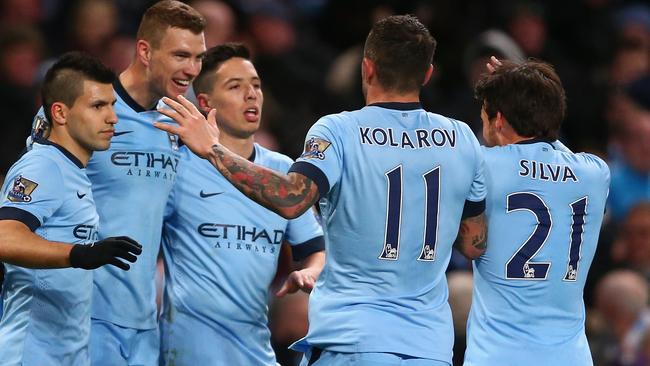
(363, 15), (436, 92)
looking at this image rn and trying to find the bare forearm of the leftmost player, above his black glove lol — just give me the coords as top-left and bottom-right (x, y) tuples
(0, 220), (72, 268)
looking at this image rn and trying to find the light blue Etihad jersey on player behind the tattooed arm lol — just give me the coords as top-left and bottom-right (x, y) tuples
(160, 144), (323, 365)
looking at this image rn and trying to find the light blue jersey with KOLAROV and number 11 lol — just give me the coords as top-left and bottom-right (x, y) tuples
(291, 103), (485, 363)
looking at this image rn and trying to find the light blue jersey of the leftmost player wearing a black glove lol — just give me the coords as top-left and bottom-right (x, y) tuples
(0, 141), (99, 366)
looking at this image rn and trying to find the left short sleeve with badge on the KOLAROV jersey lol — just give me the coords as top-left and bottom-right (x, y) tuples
(289, 116), (345, 197)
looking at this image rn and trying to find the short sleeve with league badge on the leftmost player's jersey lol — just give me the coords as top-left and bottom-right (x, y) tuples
(0, 155), (63, 231)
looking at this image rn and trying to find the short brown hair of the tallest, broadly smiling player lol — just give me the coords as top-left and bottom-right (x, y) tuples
(137, 0), (205, 48)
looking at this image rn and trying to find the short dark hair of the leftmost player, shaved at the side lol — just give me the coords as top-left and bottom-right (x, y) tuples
(41, 52), (115, 121)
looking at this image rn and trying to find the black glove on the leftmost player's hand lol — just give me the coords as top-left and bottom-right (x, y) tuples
(70, 236), (142, 271)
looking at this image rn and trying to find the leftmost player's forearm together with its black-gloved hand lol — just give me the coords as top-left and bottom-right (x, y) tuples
(0, 220), (142, 270)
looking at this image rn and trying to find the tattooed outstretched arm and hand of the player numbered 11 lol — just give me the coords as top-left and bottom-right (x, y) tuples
(154, 96), (319, 219)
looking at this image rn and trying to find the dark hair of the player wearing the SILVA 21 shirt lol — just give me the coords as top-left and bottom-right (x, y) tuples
(474, 60), (566, 140)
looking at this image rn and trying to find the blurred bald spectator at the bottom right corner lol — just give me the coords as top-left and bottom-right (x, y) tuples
(592, 270), (650, 366)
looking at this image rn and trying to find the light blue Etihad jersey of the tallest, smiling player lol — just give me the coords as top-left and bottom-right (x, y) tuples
(28, 81), (179, 329)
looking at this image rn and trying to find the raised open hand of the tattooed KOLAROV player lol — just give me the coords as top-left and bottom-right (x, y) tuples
(154, 95), (219, 158)
